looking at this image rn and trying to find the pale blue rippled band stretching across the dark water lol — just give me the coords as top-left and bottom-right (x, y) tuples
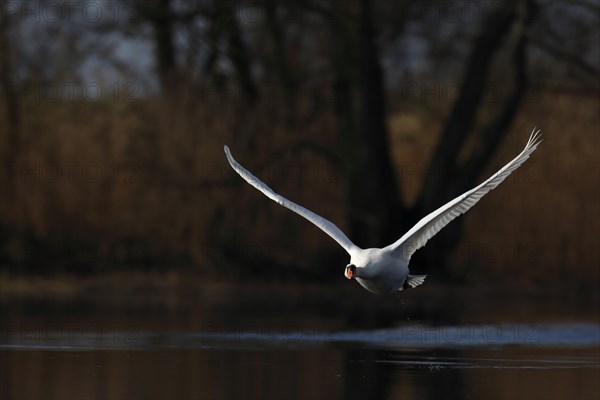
(0, 323), (600, 350)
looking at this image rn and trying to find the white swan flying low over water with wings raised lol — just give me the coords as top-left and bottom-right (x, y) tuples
(224, 128), (541, 294)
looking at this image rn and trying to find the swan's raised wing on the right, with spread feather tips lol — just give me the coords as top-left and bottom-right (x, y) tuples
(386, 129), (541, 262)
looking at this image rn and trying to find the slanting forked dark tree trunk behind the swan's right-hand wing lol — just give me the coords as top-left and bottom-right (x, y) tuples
(415, 0), (536, 276)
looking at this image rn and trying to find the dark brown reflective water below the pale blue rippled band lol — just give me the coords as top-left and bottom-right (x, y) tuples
(1, 340), (600, 399)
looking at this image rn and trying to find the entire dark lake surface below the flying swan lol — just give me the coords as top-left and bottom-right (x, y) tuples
(0, 287), (600, 399)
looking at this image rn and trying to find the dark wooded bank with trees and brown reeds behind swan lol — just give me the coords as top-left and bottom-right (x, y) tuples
(0, 0), (600, 285)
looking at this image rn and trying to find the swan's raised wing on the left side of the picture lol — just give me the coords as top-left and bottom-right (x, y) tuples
(224, 146), (359, 255)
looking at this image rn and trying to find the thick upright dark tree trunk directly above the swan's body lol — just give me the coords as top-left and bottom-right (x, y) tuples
(347, 0), (400, 247)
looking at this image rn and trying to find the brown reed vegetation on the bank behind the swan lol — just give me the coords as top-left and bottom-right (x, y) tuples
(0, 86), (600, 283)
